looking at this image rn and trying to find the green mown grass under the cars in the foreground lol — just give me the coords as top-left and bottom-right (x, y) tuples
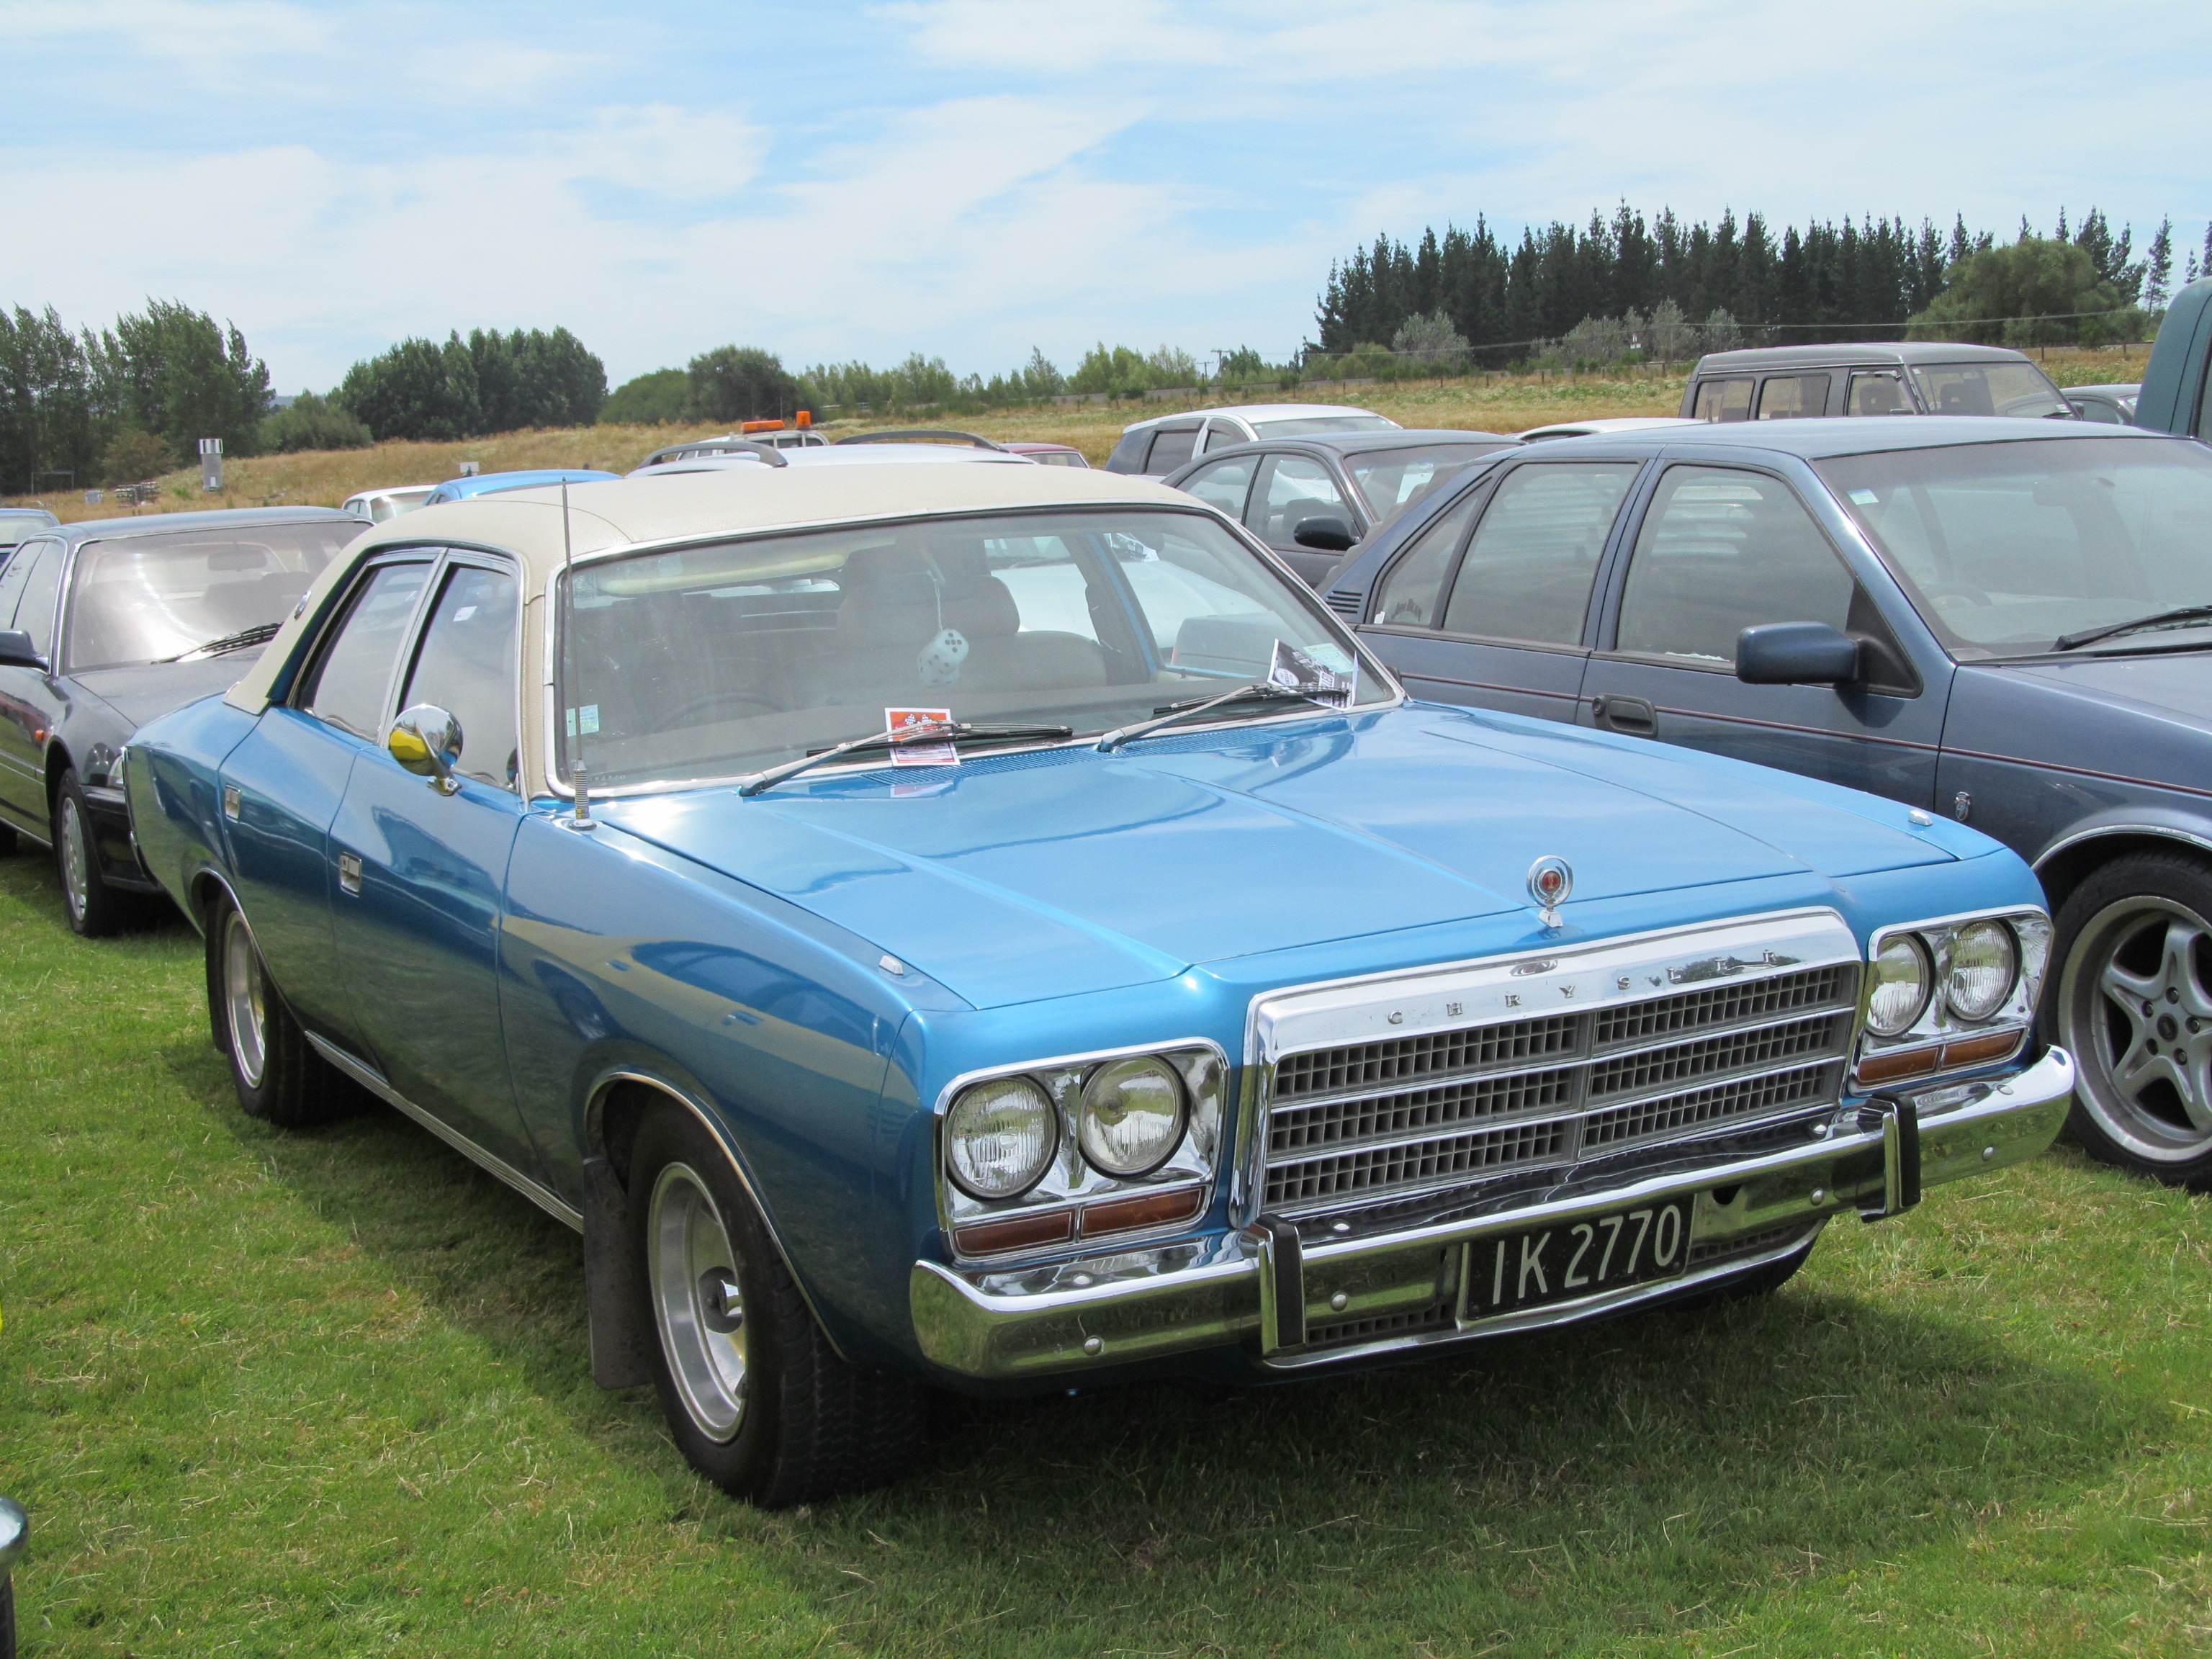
(0, 854), (2212, 1659)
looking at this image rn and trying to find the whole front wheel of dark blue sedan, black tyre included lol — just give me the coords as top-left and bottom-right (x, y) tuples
(2041, 852), (2212, 1192)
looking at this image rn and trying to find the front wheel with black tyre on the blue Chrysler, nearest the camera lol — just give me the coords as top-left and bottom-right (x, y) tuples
(628, 1106), (929, 1509)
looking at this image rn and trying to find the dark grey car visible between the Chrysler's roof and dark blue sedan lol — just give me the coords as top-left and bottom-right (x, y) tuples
(1161, 429), (1513, 586)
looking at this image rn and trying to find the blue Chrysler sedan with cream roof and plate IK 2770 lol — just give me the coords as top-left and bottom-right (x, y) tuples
(124, 467), (2072, 1504)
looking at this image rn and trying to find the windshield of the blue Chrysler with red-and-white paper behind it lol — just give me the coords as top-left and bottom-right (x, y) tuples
(557, 509), (1395, 788)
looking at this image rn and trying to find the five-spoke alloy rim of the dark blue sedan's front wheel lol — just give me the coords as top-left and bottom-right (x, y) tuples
(2059, 894), (2212, 1164)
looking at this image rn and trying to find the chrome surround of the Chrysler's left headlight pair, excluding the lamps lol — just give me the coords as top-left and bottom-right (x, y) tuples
(935, 1038), (1230, 1261)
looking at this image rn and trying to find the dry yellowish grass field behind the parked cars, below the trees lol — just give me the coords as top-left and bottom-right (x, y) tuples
(9, 345), (2144, 522)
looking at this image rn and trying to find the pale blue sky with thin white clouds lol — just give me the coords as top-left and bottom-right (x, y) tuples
(0, 0), (2212, 392)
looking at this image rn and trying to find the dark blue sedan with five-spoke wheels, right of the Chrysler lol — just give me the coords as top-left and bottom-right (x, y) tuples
(1325, 418), (2212, 1190)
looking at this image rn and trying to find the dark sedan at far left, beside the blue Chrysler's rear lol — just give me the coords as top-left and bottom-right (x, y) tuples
(0, 506), (367, 933)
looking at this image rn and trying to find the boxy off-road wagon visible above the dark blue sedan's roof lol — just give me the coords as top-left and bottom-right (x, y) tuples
(1681, 341), (2072, 423)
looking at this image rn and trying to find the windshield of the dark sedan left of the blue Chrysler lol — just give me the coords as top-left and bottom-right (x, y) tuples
(68, 520), (361, 673)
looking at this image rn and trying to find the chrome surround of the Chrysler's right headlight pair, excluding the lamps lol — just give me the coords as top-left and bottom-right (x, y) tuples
(1851, 904), (2051, 1088)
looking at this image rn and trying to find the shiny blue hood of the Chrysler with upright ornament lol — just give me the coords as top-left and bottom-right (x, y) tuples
(602, 706), (1955, 1007)
